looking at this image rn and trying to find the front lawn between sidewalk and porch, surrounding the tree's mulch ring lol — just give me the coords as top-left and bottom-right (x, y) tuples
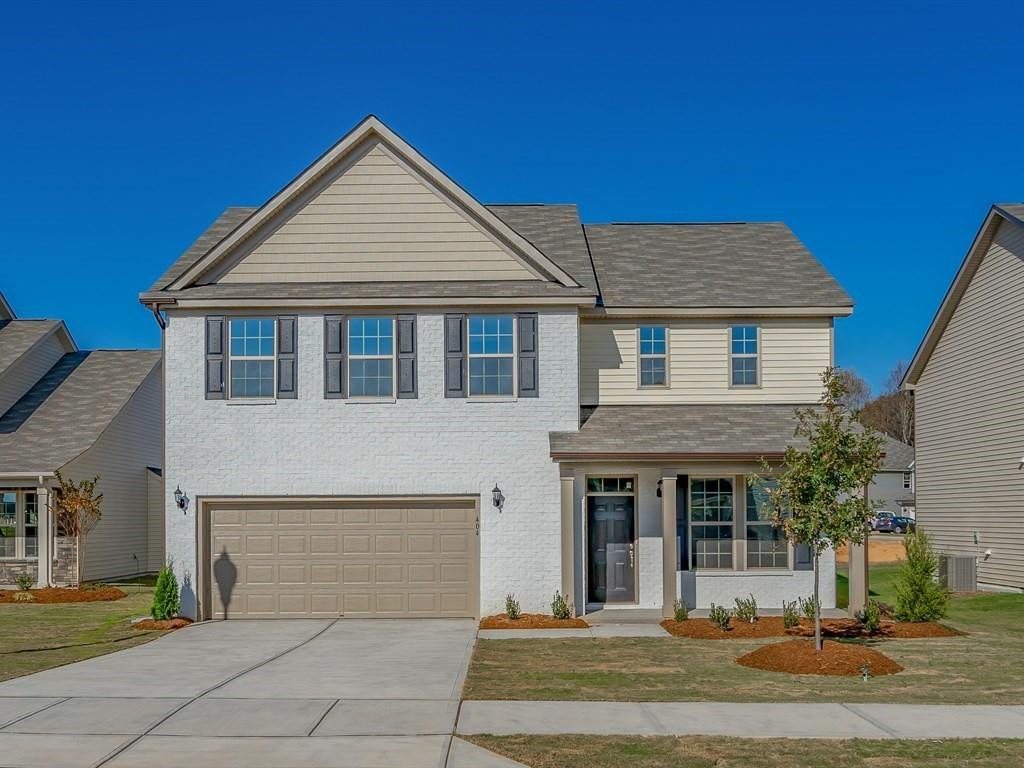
(463, 566), (1024, 705)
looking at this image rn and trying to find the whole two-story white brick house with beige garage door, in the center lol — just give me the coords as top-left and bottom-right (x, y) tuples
(140, 117), (852, 616)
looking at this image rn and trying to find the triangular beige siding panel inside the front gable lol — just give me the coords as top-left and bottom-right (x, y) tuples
(218, 143), (537, 283)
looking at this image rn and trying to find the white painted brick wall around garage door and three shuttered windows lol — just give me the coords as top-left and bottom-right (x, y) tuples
(164, 310), (579, 613)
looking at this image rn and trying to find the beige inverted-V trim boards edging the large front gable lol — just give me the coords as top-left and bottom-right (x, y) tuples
(165, 115), (577, 290)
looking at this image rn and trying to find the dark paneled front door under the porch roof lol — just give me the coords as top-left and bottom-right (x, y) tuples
(587, 496), (636, 603)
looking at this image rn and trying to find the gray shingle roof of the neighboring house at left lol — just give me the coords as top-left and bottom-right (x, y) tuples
(0, 349), (160, 473)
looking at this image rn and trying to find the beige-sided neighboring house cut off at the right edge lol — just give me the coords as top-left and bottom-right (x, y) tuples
(903, 205), (1024, 588)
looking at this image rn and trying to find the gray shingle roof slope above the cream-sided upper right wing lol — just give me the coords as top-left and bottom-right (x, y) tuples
(585, 222), (853, 308)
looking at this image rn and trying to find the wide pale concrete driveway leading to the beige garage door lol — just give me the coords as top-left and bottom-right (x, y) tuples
(0, 620), (500, 768)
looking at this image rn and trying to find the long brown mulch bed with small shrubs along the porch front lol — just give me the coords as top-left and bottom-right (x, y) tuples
(662, 616), (961, 640)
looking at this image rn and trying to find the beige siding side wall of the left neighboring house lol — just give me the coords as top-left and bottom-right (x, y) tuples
(63, 366), (163, 580)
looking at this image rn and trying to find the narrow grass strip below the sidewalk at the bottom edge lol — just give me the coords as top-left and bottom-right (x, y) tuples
(464, 735), (1024, 768)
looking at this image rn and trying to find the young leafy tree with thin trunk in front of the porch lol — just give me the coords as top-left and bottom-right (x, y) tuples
(766, 368), (882, 651)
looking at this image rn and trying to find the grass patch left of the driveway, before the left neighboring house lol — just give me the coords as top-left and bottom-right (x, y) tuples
(0, 586), (163, 681)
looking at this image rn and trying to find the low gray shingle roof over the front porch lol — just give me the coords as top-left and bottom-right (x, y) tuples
(550, 403), (807, 461)
